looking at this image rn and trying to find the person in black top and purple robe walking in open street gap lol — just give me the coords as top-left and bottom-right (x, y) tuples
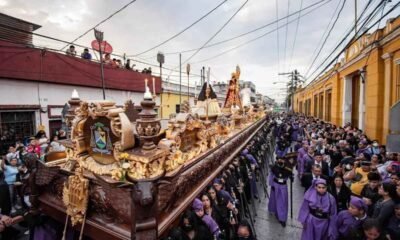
(268, 158), (293, 227)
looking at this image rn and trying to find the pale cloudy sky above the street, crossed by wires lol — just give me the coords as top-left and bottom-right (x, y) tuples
(0, 0), (399, 101)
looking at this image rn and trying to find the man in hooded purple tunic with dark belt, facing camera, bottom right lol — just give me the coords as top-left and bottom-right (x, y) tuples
(298, 179), (337, 240)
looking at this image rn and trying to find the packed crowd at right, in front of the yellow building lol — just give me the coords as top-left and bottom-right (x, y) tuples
(275, 115), (400, 240)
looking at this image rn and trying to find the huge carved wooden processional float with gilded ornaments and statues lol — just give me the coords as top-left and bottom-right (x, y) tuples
(28, 67), (265, 239)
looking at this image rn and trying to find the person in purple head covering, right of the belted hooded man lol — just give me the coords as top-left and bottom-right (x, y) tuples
(336, 196), (368, 240)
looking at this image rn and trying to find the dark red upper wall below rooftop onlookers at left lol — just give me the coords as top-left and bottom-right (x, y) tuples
(0, 41), (161, 93)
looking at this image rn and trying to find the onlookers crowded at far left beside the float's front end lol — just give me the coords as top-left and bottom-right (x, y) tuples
(0, 130), (66, 239)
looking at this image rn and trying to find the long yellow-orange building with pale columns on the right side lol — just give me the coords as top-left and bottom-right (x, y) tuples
(294, 17), (400, 143)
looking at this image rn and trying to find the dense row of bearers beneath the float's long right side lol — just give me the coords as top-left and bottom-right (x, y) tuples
(165, 124), (272, 240)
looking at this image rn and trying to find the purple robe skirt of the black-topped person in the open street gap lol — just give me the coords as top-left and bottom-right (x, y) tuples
(268, 168), (290, 222)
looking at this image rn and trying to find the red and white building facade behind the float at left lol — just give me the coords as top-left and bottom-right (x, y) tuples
(0, 14), (161, 153)
